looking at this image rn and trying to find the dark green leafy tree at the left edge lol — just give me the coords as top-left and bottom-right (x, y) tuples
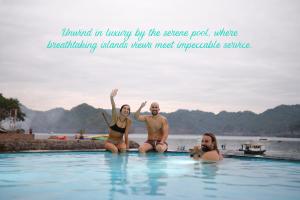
(0, 93), (25, 122)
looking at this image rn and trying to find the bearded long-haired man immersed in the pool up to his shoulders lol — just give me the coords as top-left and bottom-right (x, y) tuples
(190, 133), (223, 161)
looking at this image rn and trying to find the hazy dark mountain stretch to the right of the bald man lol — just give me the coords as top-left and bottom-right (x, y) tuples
(166, 105), (300, 137)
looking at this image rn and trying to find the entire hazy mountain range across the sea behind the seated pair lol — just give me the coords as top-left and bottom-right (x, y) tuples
(15, 103), (300, 137)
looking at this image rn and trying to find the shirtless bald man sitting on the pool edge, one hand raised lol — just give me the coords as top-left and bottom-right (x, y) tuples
(134, 102), (169, 153)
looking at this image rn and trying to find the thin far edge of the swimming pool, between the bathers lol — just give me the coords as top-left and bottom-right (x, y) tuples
(0, 149), (300, 162)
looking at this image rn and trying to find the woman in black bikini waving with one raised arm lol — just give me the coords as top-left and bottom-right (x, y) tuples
(104, 89), (132, 153)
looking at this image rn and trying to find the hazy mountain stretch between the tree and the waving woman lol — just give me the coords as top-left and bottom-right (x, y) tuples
(22, 103), (110, 133)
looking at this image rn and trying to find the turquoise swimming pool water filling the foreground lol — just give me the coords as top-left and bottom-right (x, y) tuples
(0, 152), (300, 200)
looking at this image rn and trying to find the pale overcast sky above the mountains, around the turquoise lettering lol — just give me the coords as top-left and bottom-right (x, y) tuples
(0, 0), (300, 113)
